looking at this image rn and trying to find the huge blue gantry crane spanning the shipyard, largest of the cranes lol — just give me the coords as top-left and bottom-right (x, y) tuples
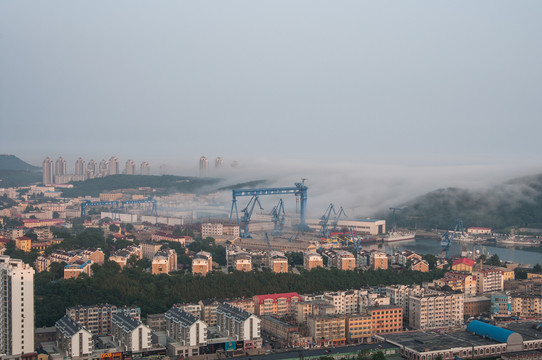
(229, 179), (310, 231)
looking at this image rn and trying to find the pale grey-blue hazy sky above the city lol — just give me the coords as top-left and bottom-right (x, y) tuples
(0, 0), (542, 183)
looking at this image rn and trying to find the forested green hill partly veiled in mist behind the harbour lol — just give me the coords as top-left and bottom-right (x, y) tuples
(381, 174), (542, 230)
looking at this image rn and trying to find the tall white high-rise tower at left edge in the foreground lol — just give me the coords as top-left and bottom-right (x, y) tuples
(0, 255), (34, 357)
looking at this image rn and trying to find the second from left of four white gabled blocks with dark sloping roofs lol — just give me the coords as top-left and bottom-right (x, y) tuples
(111, 311), (151, 352)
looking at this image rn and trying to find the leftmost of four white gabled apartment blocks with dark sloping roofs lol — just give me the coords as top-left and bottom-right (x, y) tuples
(55, 315), (94, 359)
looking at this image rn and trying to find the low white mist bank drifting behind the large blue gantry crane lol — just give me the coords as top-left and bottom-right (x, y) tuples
(202, 160), (537, 218)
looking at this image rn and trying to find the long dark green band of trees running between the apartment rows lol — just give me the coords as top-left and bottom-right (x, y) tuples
(35, 261), (442, 326)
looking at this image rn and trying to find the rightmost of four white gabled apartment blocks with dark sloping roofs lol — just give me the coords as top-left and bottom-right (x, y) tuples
(216, 303), (261, 347)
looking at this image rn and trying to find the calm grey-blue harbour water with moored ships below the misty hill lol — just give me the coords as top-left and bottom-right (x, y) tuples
(363, 238), (542, 266)
